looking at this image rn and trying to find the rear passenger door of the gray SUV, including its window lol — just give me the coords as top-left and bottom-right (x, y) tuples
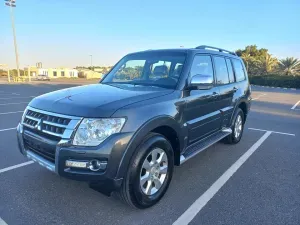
(213, 56), (237, 127)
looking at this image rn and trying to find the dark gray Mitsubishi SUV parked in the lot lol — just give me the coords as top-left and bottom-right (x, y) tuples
(17, 46), (251, 208)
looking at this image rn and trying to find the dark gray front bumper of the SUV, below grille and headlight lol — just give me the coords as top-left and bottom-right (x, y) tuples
(17, 124), (133, 189)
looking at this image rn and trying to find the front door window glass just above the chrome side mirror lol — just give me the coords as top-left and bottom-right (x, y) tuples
(190, 55), (214, 78)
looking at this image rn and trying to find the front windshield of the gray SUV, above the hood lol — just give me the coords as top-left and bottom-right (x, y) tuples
(101, 51), (186, 89)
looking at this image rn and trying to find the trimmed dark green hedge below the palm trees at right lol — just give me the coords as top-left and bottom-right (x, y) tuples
(249, 75), (300, 88)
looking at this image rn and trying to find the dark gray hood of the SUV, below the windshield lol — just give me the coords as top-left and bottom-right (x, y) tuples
(29, 84), (174, 118)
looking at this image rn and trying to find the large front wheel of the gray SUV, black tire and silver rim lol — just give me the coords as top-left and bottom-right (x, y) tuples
(117, 133), (174, 209)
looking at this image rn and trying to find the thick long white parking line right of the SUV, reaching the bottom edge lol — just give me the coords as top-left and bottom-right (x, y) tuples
(173, 131), (272, 225)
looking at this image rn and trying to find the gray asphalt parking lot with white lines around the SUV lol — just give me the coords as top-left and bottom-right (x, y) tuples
(0, 84), (300, 225)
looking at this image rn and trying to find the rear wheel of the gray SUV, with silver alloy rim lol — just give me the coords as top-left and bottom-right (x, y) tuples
(224, 108), (245, 144)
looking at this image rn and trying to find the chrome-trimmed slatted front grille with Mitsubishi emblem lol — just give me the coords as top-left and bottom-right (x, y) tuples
(22, 106), (82, 139)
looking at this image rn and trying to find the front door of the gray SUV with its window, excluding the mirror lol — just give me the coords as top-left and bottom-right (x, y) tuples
(184, 55), (221, 145)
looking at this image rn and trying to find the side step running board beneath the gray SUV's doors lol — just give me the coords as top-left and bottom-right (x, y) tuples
(180, 128), (232, 165)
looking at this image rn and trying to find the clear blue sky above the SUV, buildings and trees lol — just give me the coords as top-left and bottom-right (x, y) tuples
(0, 0), (300, 68)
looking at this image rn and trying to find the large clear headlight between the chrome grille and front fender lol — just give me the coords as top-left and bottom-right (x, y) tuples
(73, 118), (125, 146)
